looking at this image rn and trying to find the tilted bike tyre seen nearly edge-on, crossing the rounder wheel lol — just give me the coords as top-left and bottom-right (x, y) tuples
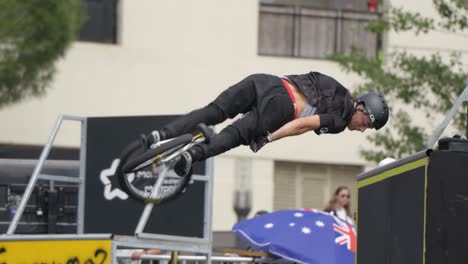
(122, 134), (192, 173)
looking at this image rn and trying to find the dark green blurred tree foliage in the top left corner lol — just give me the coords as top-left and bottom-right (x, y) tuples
(0, 0), (83, 109)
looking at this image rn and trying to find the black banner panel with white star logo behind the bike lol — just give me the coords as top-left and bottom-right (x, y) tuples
(84, 116), (205, 237)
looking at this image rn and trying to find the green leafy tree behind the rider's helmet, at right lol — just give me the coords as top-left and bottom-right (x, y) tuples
(330, 0), (468, 161)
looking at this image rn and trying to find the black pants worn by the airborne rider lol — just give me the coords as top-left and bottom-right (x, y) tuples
(162, 74), (294, 160)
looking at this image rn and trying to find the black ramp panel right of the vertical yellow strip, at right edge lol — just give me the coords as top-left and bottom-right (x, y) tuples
(426, 151), (468, 264)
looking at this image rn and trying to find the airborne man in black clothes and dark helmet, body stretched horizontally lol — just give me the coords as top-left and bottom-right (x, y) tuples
(142, 72), (389, 174)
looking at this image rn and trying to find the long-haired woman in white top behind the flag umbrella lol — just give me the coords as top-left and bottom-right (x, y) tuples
(324, 186), (354, 225)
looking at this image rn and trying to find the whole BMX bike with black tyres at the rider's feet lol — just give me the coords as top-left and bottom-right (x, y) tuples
(116, 125), (213, 204)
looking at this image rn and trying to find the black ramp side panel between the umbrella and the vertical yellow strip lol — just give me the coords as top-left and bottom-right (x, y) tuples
(357, 165), (425, 264)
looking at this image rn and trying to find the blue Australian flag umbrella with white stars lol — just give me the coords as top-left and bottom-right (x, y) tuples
(233, 209), (356, 264)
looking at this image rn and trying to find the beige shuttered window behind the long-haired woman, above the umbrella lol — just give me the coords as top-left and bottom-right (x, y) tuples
(273, 162), (362, 210)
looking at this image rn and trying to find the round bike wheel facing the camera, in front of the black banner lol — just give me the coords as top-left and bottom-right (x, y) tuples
(116, 135), (192, 203)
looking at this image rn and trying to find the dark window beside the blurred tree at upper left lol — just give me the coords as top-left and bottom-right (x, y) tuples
(78, 0), (118, 43)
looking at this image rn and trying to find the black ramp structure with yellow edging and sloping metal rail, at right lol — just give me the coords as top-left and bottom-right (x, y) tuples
(356, 86), (468, 264)
